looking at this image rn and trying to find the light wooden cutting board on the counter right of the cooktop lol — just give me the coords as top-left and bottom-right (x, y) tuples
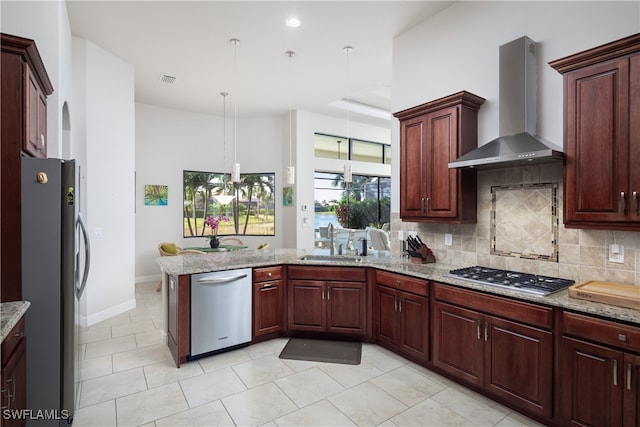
(569, 280), (640, 310)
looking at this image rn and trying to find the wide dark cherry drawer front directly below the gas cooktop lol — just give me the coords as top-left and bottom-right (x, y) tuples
(434, 284), (553, 329)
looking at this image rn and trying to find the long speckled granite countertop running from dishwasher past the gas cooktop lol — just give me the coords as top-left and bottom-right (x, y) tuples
(156, 249), (640, 326)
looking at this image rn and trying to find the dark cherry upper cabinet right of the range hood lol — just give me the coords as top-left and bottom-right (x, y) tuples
(549, 34), (640, 230)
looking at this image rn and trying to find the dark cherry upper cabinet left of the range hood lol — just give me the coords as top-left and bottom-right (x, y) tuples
(394, 91), (484, 223)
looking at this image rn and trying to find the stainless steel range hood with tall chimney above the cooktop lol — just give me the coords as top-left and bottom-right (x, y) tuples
(449, 36), (564, 169)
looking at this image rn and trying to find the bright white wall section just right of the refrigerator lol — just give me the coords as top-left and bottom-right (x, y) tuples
(72, 38), (135, 325)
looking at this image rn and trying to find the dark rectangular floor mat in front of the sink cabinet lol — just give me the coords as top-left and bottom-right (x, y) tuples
(280, 338), (362, 365)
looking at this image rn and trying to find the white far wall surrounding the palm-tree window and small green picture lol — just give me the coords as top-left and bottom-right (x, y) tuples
(135, 100), (288, 281)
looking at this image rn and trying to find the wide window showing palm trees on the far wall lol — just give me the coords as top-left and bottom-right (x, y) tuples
(182, 170), (275, 237)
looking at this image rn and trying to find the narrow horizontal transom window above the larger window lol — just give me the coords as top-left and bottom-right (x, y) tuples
(314, 133), (391, 164)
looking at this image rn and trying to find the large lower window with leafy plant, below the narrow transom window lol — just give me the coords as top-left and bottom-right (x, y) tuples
(314, 172), (391, 229)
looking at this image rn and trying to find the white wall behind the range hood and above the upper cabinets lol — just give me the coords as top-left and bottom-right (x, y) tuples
(391, 1), (640, 212)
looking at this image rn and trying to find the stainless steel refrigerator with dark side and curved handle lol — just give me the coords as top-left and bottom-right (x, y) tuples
(21, 157), (90, 426)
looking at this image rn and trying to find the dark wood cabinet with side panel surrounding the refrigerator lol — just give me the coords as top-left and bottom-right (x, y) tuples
(0, 34), (53, 301)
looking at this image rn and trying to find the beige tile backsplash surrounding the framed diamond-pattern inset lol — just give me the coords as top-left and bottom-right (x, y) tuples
(391, 164), (640, 286)
